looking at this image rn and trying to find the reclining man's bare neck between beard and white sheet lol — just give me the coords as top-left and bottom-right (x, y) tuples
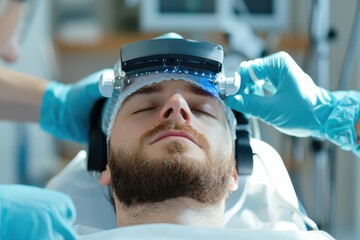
(116, 198), (224, 228)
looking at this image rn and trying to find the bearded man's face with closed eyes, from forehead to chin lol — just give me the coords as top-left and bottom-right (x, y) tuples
(109, 80), (235, 206)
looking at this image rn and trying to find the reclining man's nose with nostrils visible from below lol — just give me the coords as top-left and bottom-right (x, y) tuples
(160, 93), (191, 124)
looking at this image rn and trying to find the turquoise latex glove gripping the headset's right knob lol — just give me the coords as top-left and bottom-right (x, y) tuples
(226, 52), (360, 155)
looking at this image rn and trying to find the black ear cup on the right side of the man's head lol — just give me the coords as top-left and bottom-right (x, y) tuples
(233, 111), (254, 175)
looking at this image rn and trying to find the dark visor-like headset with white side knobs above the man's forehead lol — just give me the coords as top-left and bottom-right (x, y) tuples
(99, 38), (240, 98)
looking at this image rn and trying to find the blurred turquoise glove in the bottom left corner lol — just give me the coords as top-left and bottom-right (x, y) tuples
(0, 185), (75, 240)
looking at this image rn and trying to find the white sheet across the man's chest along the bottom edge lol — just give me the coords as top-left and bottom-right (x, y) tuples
(78, 224), (334, 240)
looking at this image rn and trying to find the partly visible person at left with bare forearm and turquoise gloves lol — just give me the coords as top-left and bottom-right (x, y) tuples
(0, 0), (107, 240)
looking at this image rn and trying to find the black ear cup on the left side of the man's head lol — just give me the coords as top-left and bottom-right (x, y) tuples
(87, 98), (107, 172)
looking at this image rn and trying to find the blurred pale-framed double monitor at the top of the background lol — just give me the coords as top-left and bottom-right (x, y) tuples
(140, 0), (289, 31)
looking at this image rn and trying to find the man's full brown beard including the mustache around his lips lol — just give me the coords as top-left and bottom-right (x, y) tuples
(109, 122), (235, 206)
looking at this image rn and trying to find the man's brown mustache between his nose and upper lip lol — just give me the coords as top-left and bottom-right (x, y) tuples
(140, 121), (209, 147)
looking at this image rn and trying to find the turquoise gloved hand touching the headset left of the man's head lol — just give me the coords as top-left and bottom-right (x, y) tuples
(40, 69), (108, 143)
